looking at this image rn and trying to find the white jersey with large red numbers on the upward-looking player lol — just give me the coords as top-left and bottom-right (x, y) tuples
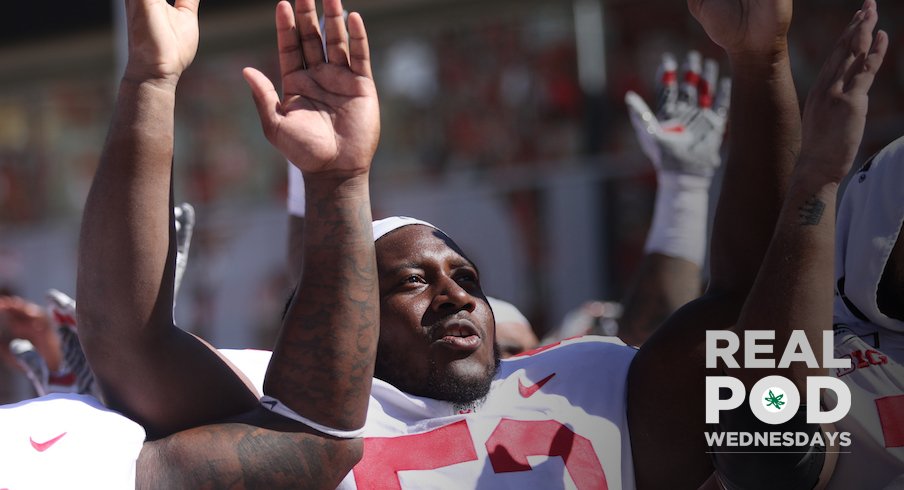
(229, 336), (636, 490)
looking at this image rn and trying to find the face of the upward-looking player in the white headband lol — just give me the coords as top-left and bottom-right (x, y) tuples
(375, 225), (498, 403)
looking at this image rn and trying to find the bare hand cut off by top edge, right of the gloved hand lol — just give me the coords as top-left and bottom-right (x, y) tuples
(687, 0), (792, 54)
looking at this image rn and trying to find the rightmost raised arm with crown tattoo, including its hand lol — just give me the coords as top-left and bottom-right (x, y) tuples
(714, 5), (888, 488)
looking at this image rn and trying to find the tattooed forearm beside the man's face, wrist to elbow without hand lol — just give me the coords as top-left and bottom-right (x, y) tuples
(264, 177), (379, 429)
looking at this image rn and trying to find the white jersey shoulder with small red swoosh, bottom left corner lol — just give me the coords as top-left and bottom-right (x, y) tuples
(0, 394), (145, 490)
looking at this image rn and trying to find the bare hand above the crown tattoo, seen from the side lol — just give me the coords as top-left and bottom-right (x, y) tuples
(800, 0), (888, 182)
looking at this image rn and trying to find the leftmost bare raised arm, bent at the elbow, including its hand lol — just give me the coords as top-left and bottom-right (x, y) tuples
(77, 0), (257, 437)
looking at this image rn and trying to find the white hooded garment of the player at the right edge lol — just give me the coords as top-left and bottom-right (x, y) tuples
(827, 138), (904, 490)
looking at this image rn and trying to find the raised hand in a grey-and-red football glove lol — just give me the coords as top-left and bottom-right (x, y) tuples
(625, 51), (731, 177)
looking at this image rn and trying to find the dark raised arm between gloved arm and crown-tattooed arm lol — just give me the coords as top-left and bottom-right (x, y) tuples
(628, 0), (800, 488)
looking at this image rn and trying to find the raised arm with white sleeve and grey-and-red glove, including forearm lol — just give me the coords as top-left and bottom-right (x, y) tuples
(618, 51), (731, 345)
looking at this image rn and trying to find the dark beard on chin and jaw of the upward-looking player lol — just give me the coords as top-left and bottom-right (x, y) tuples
(374, 342), (500, 405)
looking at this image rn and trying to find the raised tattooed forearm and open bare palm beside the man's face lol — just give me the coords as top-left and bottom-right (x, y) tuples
(245, 0), (380, 430)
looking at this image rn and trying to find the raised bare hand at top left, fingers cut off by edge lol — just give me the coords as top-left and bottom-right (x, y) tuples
(124, 0), (199, 86)
